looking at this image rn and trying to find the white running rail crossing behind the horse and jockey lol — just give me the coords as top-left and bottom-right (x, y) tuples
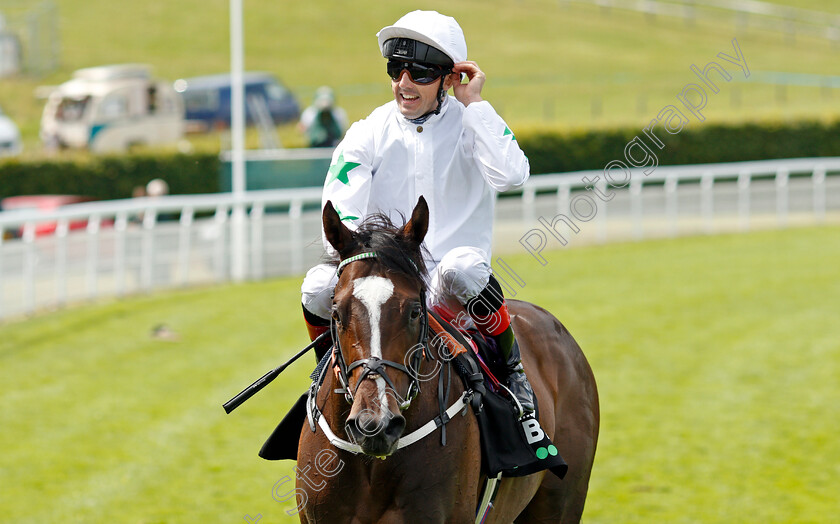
(0, 157), (840, 321)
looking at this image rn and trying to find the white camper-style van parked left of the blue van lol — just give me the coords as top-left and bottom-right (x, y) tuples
(41, 64), (184, 152)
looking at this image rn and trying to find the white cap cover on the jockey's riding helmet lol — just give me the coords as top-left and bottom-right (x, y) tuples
(376, 11), (467, 63)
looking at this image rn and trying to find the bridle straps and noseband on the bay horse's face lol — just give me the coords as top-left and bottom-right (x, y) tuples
(330, 251), (435, 410)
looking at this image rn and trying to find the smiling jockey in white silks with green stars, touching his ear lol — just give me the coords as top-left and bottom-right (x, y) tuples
(301, 11), (534, 411)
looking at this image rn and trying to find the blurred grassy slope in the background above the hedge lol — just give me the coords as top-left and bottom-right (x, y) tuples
(0, 0), (840, 155)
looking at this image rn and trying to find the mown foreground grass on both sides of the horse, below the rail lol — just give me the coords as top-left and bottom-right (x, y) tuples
(0, 227), (840, 524)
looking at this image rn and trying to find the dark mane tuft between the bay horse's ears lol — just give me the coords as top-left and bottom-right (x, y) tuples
(334, 213), (427, 290)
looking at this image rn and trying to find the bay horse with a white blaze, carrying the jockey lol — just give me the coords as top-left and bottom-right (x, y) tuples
(296, 197), (600, 524)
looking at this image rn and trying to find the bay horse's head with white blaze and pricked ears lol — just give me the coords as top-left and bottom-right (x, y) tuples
(323, 197), (429, 457)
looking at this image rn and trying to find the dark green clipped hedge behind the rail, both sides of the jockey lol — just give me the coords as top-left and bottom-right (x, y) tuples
(0, 121), (840, 200)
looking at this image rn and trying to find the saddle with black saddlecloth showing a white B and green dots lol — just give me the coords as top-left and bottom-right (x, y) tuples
(259, 310), (568, 478)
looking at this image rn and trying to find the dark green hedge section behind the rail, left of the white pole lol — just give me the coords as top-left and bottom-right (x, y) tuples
(0, 154), (219, 200)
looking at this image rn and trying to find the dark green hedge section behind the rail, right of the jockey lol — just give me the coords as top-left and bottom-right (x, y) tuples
(516, 121), (840, 173)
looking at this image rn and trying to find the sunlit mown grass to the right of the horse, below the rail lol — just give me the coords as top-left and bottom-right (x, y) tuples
(530, 228), (840, 523)
